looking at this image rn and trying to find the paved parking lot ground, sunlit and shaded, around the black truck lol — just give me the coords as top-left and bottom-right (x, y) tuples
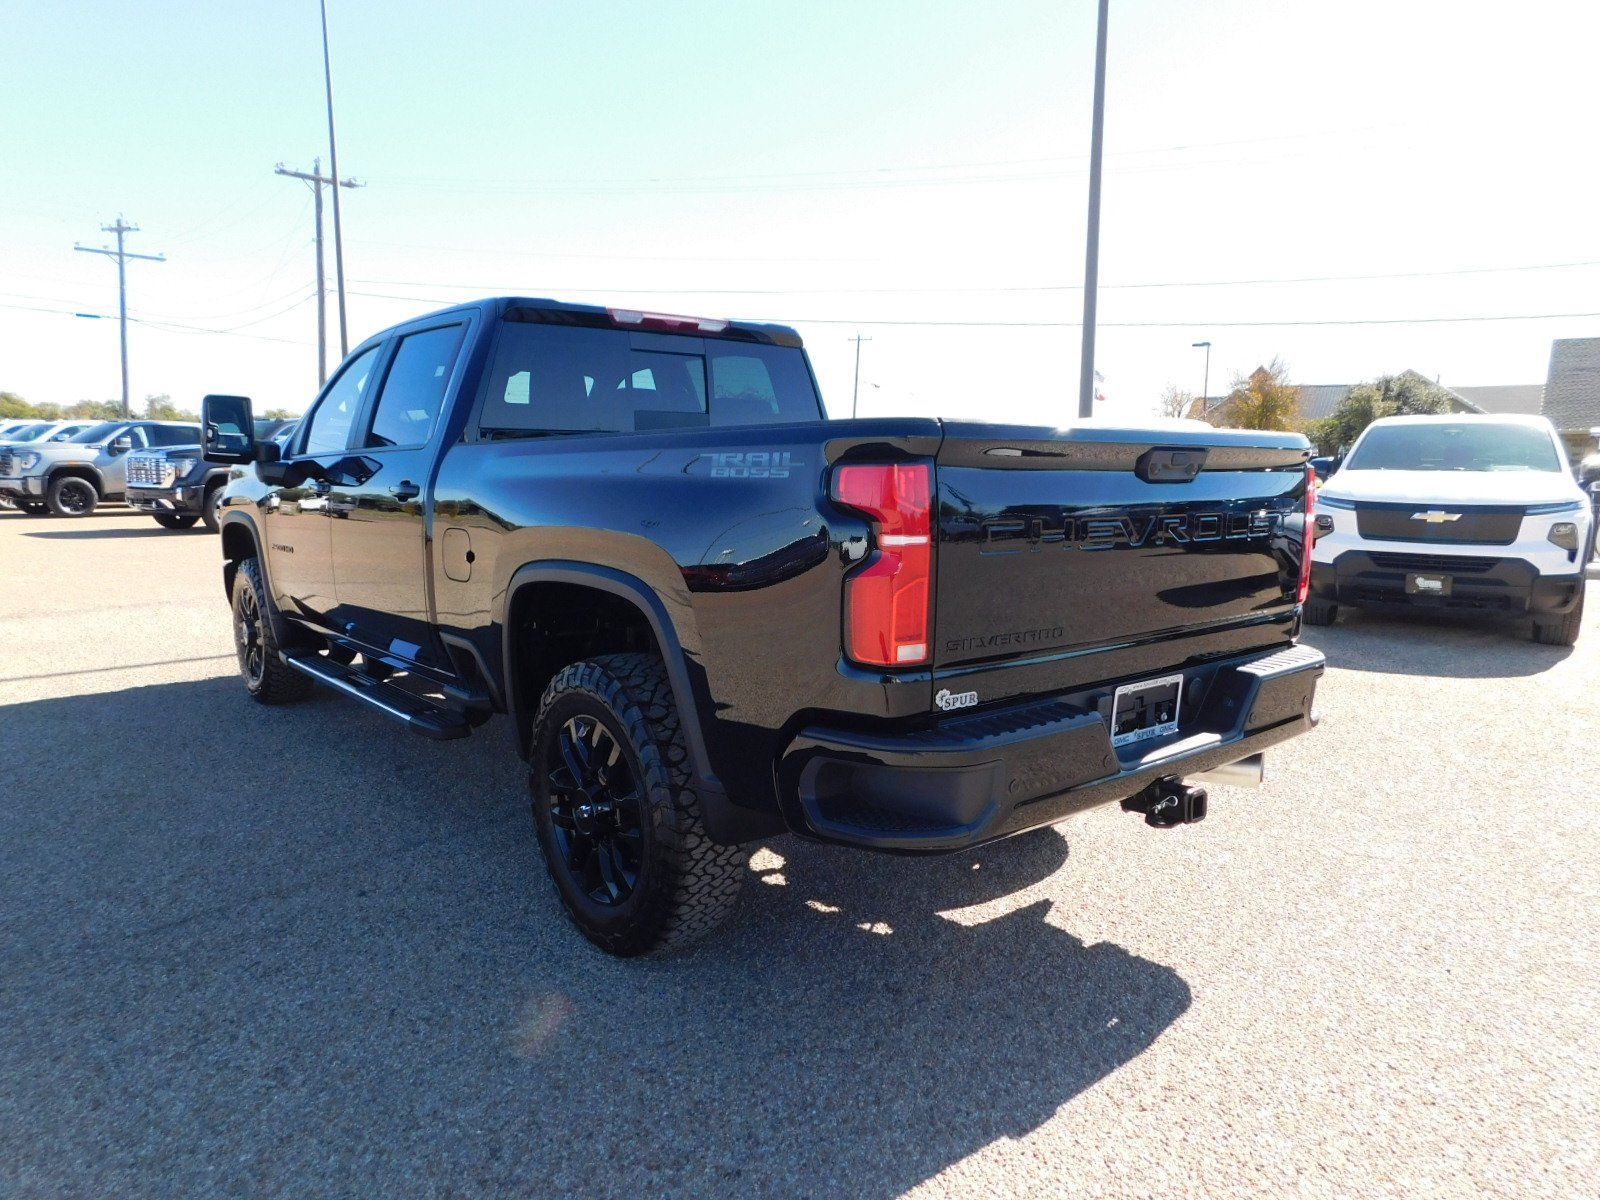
(0, 509), (1600, 1200)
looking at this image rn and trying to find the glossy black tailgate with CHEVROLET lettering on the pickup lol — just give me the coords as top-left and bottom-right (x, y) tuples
(934, 422), (1309, 701)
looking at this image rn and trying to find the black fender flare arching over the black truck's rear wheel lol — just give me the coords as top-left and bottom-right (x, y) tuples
(499, 558), (723, 795)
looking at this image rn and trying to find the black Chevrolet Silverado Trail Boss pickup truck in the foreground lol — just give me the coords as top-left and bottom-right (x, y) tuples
(205, 299), (1323, 955)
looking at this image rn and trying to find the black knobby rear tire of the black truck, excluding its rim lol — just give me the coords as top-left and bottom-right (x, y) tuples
(528, 654), (749, 957)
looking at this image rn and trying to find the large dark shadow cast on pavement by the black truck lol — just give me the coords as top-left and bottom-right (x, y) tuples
(0, 677), (1190, 1197)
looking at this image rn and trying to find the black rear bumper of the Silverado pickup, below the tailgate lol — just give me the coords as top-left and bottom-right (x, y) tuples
(778, 646), (1323, 853)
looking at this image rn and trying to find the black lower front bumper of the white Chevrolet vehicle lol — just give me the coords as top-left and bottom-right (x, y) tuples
(1310, 547), (1584, 616)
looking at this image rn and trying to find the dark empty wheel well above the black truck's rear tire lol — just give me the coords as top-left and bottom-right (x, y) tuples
(506, 581), (661, 746)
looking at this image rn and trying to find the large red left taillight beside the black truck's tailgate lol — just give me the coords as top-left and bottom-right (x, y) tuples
(834, 462), (933, 667)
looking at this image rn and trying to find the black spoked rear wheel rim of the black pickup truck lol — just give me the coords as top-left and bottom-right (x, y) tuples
(547, 714), (645, 907)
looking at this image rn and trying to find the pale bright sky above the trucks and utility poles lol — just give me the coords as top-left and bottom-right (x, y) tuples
(0, 0), (1600, 424)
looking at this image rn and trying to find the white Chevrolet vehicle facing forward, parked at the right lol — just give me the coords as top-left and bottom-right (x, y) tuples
(1306, 414), (1594, 646)
